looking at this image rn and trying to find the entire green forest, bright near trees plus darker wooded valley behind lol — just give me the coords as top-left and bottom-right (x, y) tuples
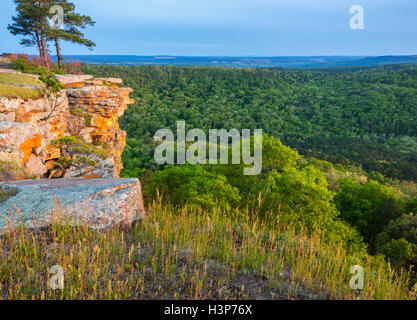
(83, 64), (417, 284)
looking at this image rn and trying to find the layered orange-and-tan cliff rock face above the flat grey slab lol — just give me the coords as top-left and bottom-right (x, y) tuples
(0, 75), (134, 179)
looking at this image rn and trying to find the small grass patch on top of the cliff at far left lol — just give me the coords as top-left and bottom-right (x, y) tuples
(0, 73), (45, 100)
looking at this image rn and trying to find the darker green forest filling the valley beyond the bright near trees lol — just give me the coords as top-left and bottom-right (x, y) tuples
(84, 65), (417, 181)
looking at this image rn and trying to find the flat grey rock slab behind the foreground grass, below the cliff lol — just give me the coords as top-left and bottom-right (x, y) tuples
(0, 179), (144, 233)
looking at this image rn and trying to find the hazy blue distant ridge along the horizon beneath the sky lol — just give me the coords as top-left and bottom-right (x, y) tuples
(53, 55), (417, 69)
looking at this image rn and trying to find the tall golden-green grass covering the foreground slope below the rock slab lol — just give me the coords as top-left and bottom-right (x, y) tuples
(0, 199), (416, 299)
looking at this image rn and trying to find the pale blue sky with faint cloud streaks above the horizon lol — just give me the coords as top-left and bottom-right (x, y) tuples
(0, 0), (417, 56)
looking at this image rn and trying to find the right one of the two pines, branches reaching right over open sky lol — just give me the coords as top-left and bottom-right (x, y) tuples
(48, 0), (95, 68)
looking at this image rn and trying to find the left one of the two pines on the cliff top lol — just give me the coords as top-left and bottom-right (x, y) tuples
(7, 0), (49, 67)
